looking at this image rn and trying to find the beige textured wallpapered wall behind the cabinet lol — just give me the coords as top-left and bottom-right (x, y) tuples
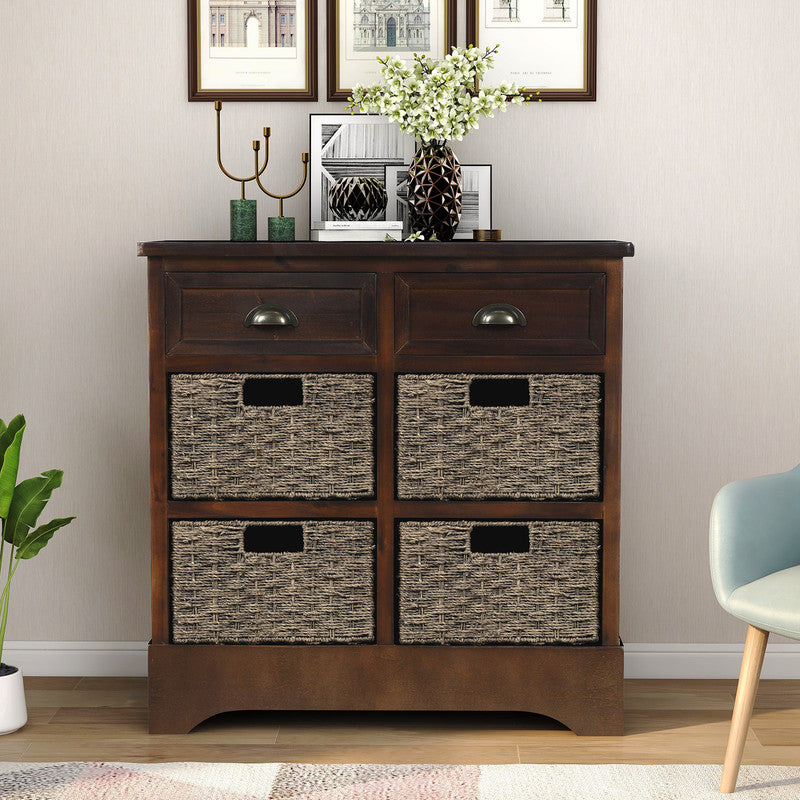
(0, 0), (800, 642)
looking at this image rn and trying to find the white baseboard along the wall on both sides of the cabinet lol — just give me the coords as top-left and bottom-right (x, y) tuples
(3, 642), (800, 680)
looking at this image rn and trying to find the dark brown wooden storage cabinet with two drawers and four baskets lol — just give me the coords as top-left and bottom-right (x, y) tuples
(139, 242), (633, 734)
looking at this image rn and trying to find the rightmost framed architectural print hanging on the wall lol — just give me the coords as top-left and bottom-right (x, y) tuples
(467, 0), (597, 100)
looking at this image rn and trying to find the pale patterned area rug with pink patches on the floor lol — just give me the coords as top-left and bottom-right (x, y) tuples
(0, 762), (800, 800)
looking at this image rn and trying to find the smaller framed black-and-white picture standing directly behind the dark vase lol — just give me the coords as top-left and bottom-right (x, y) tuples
(385, 164), (492, 239)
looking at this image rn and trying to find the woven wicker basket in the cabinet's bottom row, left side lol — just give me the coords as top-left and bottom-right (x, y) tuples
(171, 520), (375, 644)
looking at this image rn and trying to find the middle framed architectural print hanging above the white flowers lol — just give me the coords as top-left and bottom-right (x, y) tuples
(327, 0), (457, 100)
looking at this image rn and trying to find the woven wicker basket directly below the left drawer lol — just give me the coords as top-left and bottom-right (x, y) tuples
(170, 373), (375, 499)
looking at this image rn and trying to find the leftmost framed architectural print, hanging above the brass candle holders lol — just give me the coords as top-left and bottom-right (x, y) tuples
(188, 0), (317, 100)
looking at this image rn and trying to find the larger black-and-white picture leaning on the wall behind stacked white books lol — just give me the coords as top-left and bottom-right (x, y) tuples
(309, 114), (414, 228)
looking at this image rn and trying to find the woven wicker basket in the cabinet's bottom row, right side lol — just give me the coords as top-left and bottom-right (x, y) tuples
(398, 520), (600, 644)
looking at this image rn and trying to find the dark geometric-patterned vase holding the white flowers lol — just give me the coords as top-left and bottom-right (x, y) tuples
(408, 141), (462, 242)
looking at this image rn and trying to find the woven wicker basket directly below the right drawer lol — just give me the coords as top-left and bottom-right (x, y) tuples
(397, 374), (601, 500)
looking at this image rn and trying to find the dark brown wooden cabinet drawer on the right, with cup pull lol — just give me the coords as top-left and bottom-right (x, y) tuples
(395, 272), (606, 355)
